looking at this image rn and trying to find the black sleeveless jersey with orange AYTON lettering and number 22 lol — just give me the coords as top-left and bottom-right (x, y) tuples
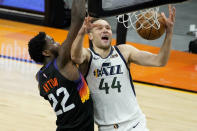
(37, 60), (94, 131)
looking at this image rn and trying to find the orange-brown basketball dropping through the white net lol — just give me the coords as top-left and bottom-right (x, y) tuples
(136, 12), (165, 40)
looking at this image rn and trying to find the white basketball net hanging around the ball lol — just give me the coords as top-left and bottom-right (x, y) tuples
(117, 7), (160, 30)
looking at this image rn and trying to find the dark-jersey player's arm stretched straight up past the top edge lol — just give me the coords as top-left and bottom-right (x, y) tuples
(57, 0), (85, 68)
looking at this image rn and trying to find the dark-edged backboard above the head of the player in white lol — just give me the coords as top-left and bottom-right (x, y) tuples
(88, 0), (188, 17)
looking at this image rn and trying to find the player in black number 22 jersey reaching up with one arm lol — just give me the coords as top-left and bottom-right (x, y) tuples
(28, 0), (94, 131)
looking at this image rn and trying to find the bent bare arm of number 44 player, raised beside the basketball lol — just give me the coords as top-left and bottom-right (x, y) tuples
(119, 5), (175, 66)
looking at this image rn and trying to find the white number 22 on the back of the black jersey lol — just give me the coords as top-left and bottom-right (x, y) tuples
(48, 87), (75, 116)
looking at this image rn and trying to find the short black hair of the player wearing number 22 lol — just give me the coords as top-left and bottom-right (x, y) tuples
(28, 32), (46, 63)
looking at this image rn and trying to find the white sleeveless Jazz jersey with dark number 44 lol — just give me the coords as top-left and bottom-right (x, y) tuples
(86, 47), (144, 125)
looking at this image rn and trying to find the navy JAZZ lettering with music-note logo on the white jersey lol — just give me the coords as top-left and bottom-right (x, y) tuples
(93, 63), (123, 77)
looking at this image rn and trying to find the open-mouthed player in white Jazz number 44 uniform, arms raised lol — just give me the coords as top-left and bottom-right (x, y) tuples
(71, 5), (175, 131)
